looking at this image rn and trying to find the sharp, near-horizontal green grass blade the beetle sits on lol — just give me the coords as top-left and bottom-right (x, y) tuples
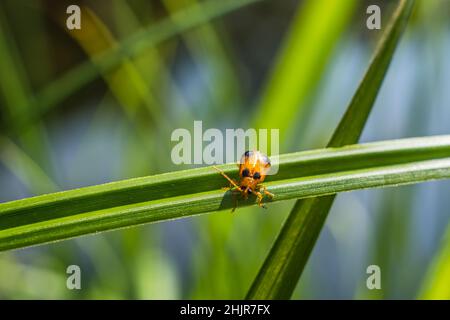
(0, 136), (450, 251)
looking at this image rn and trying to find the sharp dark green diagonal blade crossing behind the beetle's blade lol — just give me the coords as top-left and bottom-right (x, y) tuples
(247, 0), (413, 299)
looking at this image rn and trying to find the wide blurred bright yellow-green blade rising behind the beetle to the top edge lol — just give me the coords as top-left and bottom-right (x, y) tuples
(255, 0), (357, 141)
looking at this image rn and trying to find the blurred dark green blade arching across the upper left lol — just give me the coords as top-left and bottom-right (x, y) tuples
(11, 0), (260, 129)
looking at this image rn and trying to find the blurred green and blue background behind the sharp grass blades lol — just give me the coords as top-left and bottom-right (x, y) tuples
(0, 0), (450, 299)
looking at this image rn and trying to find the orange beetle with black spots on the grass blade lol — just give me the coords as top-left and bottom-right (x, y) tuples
(214, 151), (274, 211)
